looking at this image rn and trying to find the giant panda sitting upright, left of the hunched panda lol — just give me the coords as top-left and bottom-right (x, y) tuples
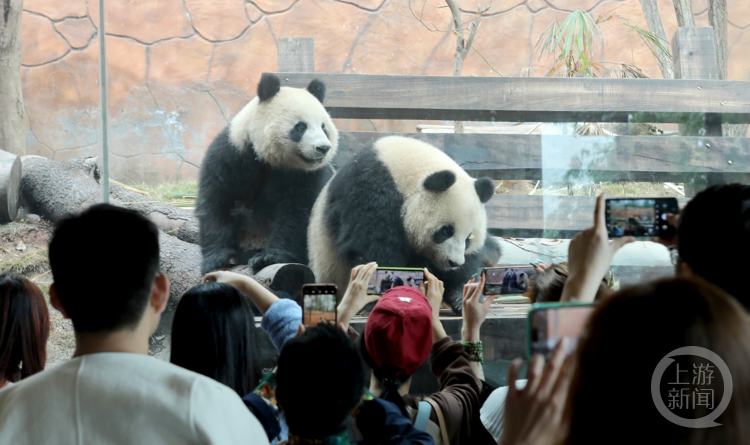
(200, 74), (338, 273)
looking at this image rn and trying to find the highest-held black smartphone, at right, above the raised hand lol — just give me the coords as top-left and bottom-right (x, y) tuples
(605, 198), (680, 238)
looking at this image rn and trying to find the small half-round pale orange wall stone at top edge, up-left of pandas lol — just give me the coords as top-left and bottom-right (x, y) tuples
(185, 0), (250, 42)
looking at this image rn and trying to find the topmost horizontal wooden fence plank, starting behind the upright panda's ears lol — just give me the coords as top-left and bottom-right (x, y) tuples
(270, 73), (750, 123)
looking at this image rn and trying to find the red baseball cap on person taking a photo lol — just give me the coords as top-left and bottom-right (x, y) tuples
(365, 286), (432, 376)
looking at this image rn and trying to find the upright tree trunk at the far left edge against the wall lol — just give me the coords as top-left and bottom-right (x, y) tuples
(0, 0), (26, 155)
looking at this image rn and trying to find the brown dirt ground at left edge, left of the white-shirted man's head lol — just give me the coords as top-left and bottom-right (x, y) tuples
(0, 220), (75, 368)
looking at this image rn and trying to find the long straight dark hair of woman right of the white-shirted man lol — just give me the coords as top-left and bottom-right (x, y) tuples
(170, 283), (258, 397)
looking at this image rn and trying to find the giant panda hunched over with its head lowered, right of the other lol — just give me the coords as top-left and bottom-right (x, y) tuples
(308, 136), (500, 313)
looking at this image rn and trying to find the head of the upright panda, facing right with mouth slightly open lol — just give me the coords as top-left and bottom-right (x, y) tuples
(230, 74), (338, 170)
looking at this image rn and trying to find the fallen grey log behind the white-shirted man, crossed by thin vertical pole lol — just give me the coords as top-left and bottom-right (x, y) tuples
(22, 156), (198, 244)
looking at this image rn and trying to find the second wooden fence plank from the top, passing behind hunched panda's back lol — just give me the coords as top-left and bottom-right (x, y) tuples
(333, 131), (750, 184)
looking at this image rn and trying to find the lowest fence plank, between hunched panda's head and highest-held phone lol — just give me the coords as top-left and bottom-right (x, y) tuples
(485, 195), (688, 238)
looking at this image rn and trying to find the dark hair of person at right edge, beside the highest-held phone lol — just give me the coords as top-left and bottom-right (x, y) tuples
(677, 184), (750, 309)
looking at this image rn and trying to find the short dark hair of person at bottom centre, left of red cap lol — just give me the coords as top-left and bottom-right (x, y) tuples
(276, 323), (364, 440)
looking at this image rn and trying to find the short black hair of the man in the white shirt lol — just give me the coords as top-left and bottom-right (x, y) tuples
(49, 204), (159, 332)
